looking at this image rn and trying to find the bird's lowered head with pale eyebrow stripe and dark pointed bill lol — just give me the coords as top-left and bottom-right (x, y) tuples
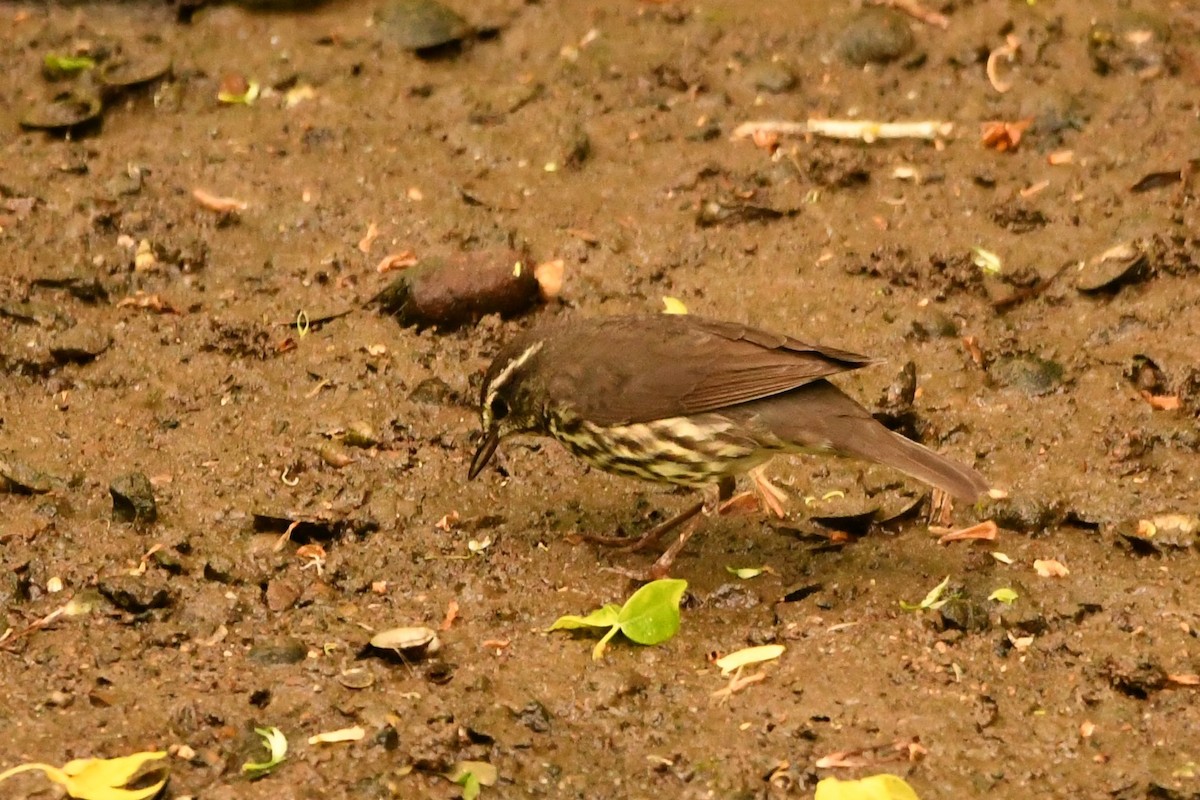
(467, 338), (544, 479)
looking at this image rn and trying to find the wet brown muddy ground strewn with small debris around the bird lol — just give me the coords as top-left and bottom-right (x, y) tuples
(0, 0), (1200, 800)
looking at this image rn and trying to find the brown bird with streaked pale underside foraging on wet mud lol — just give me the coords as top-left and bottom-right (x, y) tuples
(468, 314), (989, 578)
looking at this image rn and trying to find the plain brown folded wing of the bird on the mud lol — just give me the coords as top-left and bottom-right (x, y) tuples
(541, 314), (874, 425)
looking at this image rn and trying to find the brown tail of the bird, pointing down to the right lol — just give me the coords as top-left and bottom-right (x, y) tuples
(743, 380), (989, 501)
